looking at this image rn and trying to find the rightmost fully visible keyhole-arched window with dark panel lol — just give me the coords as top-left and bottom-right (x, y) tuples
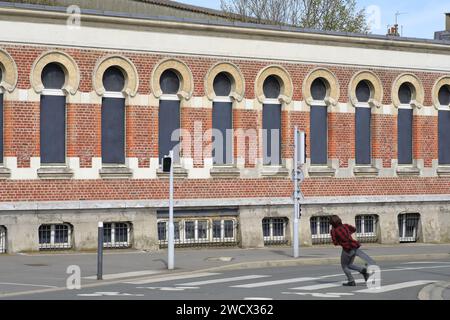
(398, 82), (414, 165)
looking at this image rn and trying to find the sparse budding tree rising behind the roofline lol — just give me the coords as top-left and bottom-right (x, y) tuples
(221, 0), (369, 33)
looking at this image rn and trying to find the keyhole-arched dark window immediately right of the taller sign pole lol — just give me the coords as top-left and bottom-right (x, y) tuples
(310, 78), (328, 165)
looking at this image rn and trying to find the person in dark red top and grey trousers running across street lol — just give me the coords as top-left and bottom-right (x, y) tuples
(330, 216), (375, 287)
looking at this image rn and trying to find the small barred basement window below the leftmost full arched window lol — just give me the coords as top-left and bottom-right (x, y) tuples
(39, 224), (72, 250)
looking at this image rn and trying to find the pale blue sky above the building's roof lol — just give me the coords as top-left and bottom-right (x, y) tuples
(178, 0), (450, 39)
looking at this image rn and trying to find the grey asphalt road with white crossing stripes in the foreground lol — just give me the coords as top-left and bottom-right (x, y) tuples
(3, 260), (450, 301)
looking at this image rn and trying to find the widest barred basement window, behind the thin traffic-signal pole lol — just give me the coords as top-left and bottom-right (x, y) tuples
(158, 218), (239, 248)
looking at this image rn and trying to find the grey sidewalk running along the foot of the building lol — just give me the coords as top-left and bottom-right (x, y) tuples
(0, 244), (450, 292)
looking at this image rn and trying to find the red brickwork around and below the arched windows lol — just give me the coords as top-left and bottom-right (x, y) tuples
(0, 45), (450, 201)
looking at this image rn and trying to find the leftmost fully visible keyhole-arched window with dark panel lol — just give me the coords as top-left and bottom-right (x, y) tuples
(40, 63), (66, 164)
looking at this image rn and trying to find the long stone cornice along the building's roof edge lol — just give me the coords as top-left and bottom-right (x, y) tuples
(0, 7), (450, 55)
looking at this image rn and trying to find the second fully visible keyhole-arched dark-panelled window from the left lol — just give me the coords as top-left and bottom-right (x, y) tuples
(102, 67), (125, 165)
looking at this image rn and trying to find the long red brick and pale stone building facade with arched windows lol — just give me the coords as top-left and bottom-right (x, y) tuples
(0, 1), (450, 252)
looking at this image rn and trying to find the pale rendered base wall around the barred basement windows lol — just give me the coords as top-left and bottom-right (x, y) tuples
(0, 202), (450, 253)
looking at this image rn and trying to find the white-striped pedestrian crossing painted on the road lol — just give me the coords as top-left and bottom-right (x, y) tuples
(117, 265), (450, 298)
